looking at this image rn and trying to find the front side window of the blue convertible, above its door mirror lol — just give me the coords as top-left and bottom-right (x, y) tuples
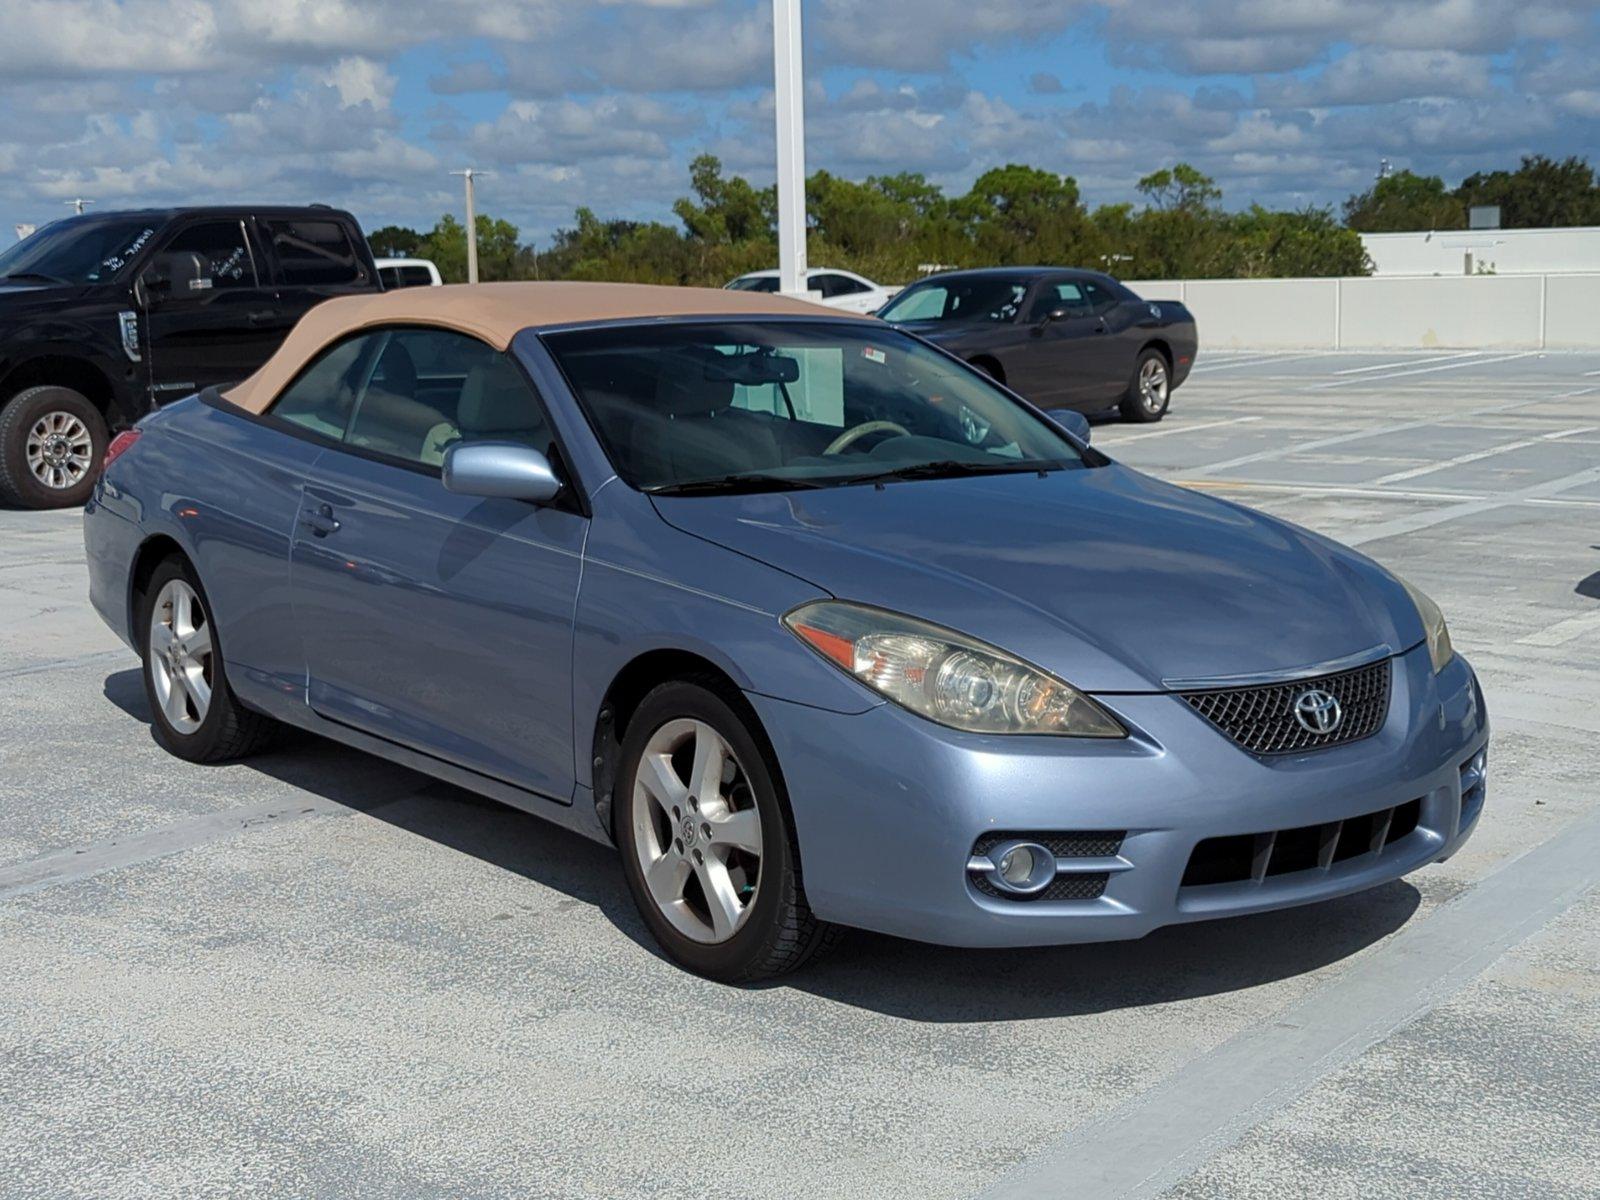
(346, 328), (554, 467)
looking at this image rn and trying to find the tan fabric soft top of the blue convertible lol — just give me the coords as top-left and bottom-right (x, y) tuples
(224, 282), (870, 413)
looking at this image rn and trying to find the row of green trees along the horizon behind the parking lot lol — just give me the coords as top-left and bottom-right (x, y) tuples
(370, 154), (1600, 286)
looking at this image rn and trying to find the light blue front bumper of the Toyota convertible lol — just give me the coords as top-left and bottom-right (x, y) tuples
(750, 646), (1488, 946)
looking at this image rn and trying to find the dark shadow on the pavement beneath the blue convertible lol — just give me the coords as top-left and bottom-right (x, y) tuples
(104, 670), (1421, 1022)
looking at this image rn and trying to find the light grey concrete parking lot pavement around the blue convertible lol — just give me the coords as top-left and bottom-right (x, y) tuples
(0, 352), (1600, 1200)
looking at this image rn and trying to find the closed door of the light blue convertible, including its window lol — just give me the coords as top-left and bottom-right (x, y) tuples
(274, 328), (587, 802)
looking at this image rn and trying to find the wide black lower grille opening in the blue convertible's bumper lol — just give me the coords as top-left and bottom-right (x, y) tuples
(1182, 798), (1422, 888)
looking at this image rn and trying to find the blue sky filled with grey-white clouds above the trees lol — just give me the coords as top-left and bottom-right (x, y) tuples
(0, 0), (1600, 240)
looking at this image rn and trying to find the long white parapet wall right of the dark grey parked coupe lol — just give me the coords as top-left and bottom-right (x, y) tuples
(1128, 272), (1600, 350)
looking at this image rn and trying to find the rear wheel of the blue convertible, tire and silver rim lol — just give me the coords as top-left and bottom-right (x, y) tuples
(139, 557), (280, 763)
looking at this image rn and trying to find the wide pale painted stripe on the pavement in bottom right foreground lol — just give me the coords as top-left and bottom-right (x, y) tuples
(981, 803), (1600, 1200)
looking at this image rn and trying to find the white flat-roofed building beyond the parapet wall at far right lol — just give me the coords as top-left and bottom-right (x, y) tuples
(1362, 226), (1600, 275)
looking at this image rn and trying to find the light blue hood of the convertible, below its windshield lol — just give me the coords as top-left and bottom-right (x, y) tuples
(654, 464), (1422, 691)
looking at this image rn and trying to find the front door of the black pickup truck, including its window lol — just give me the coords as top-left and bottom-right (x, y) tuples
(138, 218), (283, 402)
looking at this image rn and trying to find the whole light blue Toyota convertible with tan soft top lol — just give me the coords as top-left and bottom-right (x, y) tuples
(85, 283), (1488, 981)
